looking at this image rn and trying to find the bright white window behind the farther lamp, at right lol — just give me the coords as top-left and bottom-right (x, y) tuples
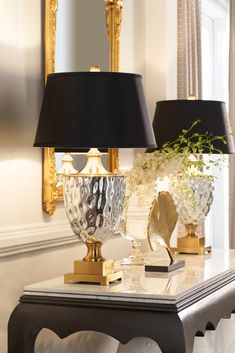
(201, 0), (229, 248)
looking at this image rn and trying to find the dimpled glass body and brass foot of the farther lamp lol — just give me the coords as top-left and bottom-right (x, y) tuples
(171, 174), (214, 255)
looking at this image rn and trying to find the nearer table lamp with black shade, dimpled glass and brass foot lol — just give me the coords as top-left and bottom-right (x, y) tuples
(34, 72), (156, 285)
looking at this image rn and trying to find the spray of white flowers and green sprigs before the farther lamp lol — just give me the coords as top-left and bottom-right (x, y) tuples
(127, 119), (226, 184)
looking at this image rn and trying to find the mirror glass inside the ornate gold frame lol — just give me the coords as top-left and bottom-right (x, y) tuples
(55, 0), (109, 177)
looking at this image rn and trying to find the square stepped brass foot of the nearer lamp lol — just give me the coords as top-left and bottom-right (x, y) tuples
(64, 260), (123, 286)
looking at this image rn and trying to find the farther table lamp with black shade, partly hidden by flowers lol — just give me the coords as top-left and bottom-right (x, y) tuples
(152, 99), (235, 254)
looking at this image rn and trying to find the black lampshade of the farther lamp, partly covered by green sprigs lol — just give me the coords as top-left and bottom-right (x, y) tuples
(151, 100), (235, 153)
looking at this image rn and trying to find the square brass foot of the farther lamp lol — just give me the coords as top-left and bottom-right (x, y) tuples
(171, 236), (211, 255)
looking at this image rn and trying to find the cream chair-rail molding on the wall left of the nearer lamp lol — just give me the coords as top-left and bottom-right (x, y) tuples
(0, 220), (78, 258)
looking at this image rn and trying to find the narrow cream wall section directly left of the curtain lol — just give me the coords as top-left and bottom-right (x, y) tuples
(145, 0), (177, 118)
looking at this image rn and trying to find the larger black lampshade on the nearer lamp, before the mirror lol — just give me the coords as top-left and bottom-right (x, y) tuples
(34, 72), (156, 148)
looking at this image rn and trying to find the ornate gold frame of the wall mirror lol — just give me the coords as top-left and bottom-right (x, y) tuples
(43, 0), (122, 215)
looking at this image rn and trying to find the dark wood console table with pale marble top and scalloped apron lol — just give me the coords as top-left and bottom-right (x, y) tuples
(8, 251), (235, 353)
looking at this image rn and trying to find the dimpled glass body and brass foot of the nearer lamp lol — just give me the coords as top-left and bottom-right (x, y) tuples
(64, 174), (125, 285)
